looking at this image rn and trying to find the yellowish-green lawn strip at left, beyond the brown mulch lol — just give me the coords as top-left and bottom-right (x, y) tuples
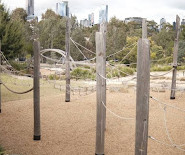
(1, 74), (94, 102)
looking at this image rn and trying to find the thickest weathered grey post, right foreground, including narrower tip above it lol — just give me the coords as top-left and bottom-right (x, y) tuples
(135, 19), (150, 155)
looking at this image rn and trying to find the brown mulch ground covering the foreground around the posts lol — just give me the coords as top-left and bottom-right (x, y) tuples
(0, 90), (185, 155)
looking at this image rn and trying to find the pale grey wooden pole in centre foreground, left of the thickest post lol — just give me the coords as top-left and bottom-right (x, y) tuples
(95, 32), (106, 155)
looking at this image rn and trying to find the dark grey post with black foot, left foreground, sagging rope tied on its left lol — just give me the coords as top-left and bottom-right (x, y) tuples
(33, 41), (41, 140)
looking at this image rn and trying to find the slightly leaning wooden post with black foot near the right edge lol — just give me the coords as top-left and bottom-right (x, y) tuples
(170, 15), (180, 100)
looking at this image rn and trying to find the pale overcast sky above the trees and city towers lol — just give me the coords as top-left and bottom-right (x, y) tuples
(2, 0), (185, 23)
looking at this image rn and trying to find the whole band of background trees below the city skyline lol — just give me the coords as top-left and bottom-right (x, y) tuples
(0, 2), (185, 68)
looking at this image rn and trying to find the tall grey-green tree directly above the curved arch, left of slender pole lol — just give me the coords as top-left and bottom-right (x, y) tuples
(38, 9), (66, 50)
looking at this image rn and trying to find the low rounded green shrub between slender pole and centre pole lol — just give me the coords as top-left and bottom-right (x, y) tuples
(71, 68), (95, 79)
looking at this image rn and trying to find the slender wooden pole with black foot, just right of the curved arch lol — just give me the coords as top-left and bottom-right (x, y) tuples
(65, 7), (70, 102)
